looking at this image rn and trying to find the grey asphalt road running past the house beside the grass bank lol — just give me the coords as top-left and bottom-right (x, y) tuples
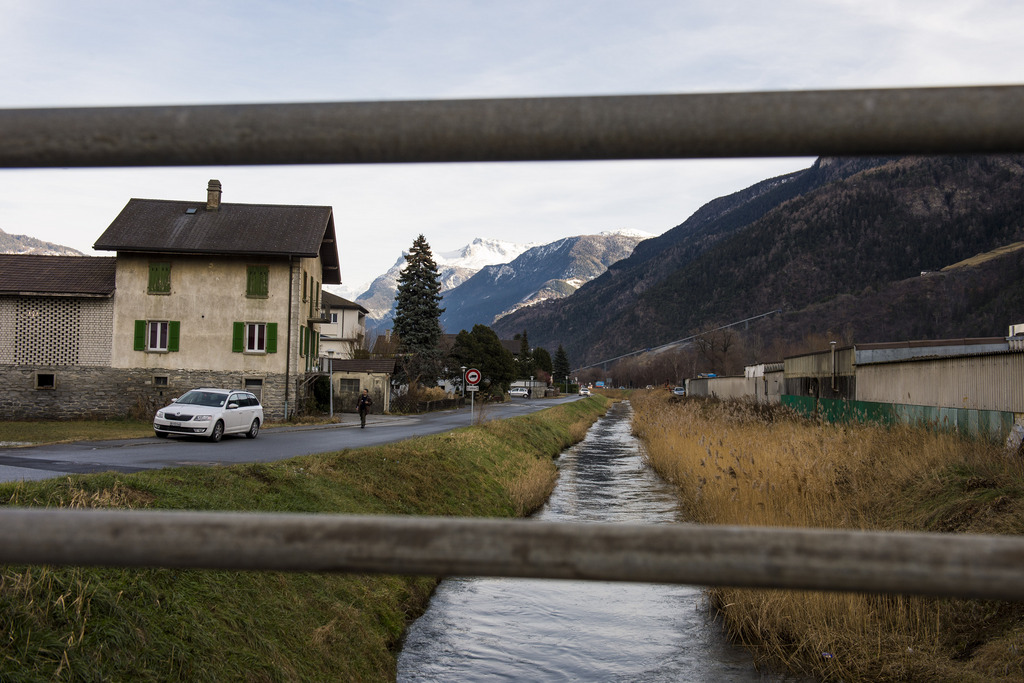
(0, 395), (579, 481)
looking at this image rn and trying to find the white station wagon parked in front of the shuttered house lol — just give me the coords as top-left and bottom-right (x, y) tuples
(153, 388), (263, 441)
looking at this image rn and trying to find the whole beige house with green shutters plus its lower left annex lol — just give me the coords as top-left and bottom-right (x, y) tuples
(0, 180), (341, 419)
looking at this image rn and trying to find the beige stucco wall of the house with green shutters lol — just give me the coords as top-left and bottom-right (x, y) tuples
(112, 253), (321, 376)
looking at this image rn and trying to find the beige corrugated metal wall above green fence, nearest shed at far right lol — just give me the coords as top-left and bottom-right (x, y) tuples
(857, 353), (1024, 413)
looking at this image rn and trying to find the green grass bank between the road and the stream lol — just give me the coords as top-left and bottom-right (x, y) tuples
(0, 396), (610, 682)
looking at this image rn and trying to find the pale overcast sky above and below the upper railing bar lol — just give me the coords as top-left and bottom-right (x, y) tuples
(0, 0), (1024, 297)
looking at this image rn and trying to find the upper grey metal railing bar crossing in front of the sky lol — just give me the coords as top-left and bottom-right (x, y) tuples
(0, 86), (1024, 168)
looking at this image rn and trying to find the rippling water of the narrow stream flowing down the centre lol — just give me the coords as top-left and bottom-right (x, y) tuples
(398, 403), (783, 681)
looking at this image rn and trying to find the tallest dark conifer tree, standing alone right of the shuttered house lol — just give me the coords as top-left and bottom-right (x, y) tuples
(394, 234), (444, 391)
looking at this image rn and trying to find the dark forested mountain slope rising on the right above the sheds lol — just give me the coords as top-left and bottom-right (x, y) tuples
(494, 155), (1024, 367)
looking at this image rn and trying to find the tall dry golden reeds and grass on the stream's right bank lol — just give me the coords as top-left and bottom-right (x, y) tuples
(631, 392), (1024, 681)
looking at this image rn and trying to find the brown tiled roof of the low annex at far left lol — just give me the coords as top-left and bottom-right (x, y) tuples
(0, 254), (117, 296)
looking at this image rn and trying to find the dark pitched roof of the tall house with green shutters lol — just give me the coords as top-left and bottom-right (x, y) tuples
(93, 199), (341, 285)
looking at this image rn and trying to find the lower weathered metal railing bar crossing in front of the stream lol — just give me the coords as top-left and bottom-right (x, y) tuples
(0, 508), (1024, 600)
